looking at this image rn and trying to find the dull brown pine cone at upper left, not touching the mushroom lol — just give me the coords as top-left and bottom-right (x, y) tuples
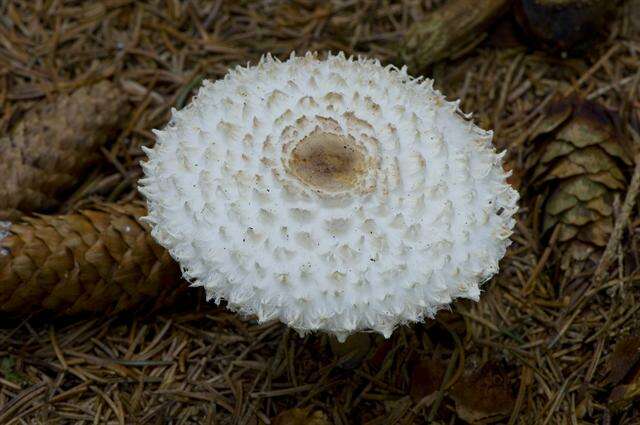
(0, 81), (129, 220)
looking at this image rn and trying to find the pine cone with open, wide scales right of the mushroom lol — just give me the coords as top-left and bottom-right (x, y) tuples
(526, 98), (631, 269)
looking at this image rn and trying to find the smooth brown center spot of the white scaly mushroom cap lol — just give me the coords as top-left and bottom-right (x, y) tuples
(288, 130), (365, 192)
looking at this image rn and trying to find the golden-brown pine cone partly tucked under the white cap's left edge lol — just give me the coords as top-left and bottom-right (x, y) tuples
(0, 204), (187, 315)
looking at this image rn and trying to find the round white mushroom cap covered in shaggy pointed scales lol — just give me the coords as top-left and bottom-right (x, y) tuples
(140, 53), (518, 338)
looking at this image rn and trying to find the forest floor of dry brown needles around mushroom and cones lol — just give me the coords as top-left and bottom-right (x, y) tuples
(0, 0), (640, 424)
